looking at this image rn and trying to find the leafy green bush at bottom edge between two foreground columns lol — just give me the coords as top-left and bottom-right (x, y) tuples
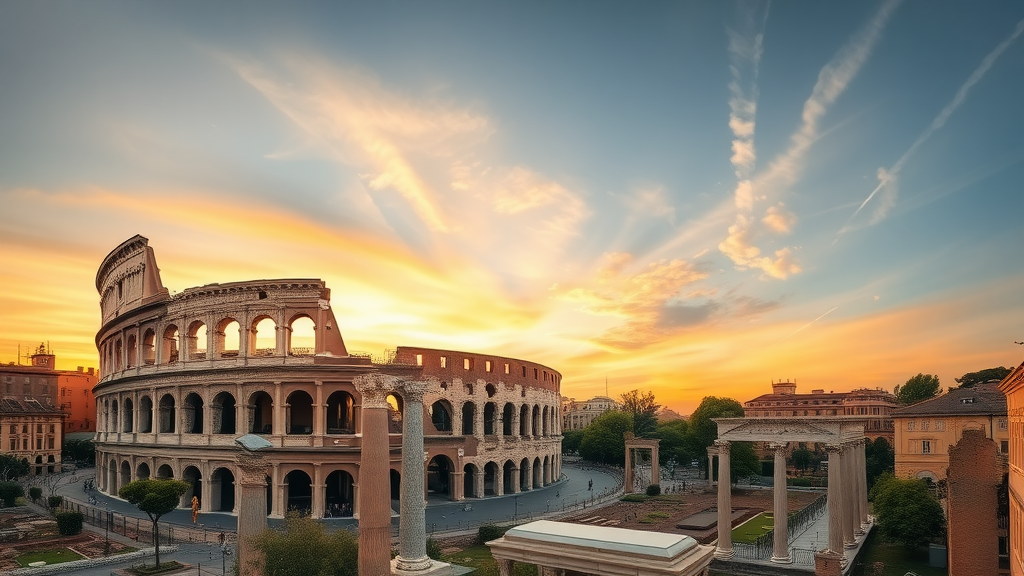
(253, 512), (358, 576)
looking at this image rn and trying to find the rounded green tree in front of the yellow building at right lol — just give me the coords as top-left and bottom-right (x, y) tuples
(870, 474), (945, 548)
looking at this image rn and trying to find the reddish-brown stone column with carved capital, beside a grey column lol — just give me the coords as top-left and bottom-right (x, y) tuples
(354, 373), (397, 576)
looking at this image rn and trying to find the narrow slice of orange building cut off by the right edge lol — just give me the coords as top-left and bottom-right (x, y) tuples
(999, 356), (1024, 576)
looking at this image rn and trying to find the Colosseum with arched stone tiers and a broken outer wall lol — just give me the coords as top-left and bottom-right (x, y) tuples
(95, 236), (561, 518)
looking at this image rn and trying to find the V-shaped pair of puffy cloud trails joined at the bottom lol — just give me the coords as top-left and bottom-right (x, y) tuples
(719, 0), (899, 279)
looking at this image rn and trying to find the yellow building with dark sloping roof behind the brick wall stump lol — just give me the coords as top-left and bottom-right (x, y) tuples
(892, 382), (1010, 483)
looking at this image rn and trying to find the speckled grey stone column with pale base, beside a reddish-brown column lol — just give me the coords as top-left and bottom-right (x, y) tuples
(393, 382), (430, 575)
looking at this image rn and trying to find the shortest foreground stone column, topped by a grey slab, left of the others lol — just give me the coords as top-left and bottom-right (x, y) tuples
(234, 446), (270, 576)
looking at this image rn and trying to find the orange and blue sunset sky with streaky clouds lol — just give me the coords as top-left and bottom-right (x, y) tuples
(0, 0), (1024, 414)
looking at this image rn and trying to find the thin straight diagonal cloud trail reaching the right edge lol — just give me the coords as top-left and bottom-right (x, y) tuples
(833, 19), (1024, 237)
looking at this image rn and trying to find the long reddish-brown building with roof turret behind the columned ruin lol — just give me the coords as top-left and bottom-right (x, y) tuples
(743, 380), (899, 444)
